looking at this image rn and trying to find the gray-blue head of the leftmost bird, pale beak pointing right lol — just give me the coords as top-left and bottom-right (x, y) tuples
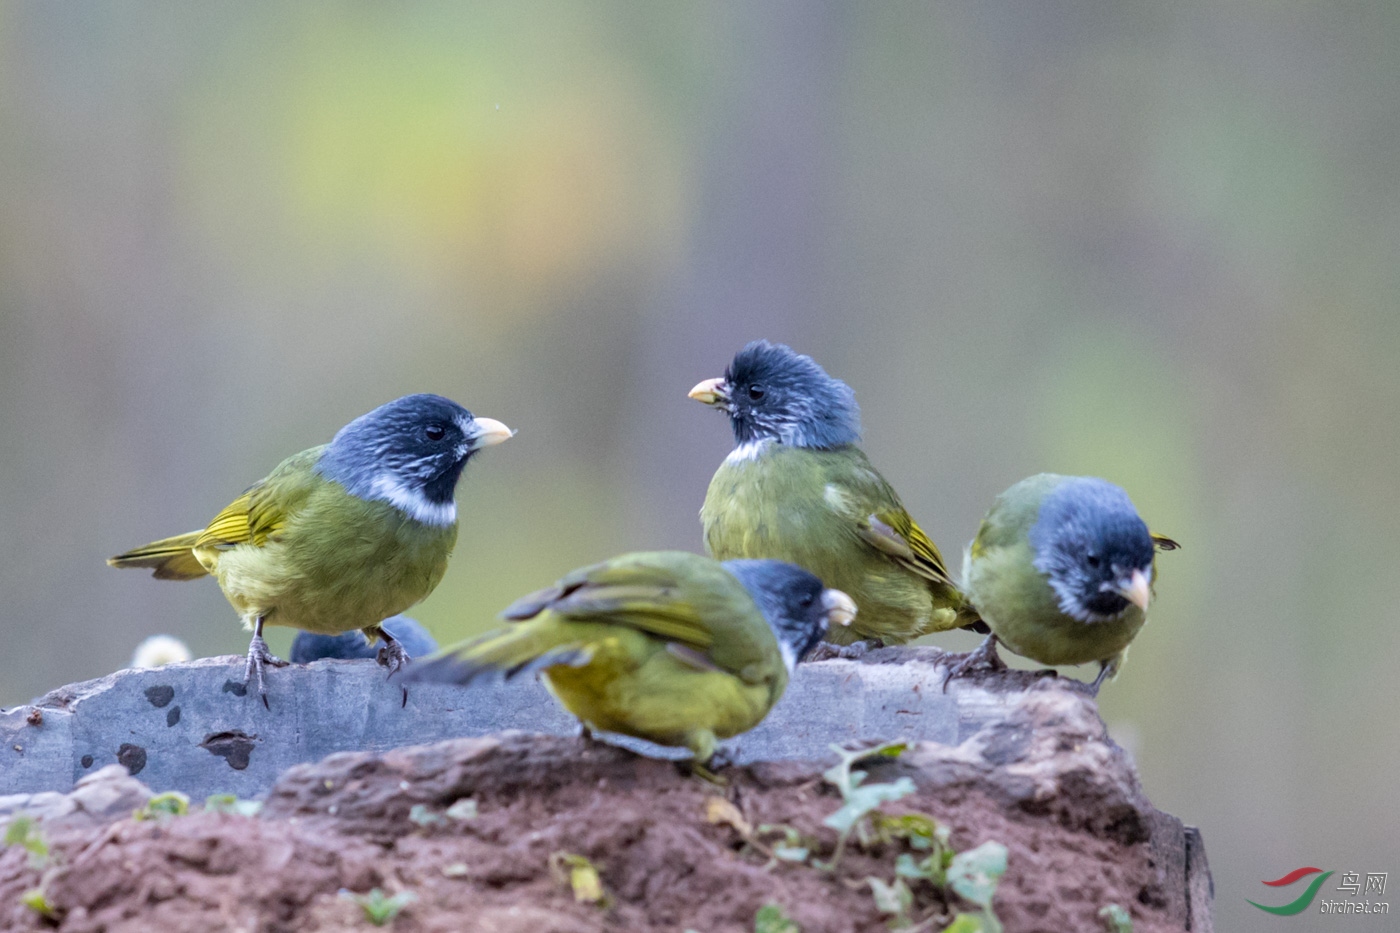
(316, 395), (512, 525)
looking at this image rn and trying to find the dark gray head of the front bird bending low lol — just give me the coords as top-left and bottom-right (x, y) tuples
(724, 560), (855, 671)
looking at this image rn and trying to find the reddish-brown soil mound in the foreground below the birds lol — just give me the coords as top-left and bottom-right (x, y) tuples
(0, 735), (1182, 933)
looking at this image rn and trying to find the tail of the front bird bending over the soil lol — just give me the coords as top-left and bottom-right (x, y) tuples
(409, 622), (592, 684)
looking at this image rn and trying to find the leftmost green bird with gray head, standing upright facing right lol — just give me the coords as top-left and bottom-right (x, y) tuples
(108, 395), (511, 706)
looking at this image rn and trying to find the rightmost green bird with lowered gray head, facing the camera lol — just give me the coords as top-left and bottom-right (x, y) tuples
(944, 474), (1179, 693)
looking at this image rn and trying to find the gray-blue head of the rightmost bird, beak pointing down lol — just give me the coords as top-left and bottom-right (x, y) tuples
(1030, 476), (1152, 622)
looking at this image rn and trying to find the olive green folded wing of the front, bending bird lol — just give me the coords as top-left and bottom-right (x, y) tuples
(503, 551), (781, 679)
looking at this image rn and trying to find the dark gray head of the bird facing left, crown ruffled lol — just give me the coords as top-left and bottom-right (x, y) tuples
(690, 340), (861, 450)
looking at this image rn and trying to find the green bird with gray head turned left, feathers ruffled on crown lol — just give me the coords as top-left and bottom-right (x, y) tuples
(690, 340), (977, 644)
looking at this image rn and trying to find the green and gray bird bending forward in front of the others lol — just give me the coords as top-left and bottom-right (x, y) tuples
(407, 551), (855, 765)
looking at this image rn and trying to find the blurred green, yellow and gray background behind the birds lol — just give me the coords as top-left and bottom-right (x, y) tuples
(0, 0), (1400, 930)
